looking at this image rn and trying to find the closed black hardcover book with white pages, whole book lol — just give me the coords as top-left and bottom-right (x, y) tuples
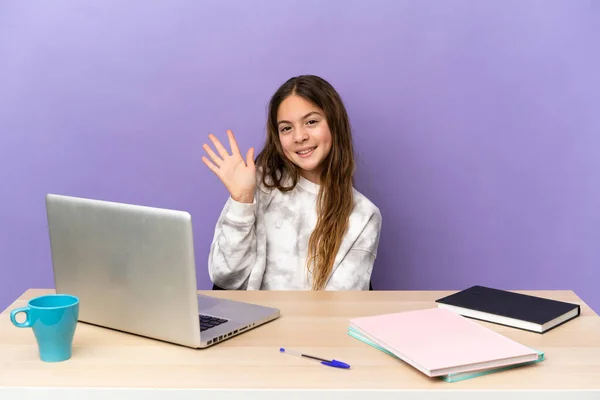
(436, 285), (581, 333)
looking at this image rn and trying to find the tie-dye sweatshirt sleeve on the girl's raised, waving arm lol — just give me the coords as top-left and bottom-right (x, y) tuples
(208, 196), (257, 290)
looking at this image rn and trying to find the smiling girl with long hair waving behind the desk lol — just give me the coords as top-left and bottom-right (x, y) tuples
(202, 75), (381, 290)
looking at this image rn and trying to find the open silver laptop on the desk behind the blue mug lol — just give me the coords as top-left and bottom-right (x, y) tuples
(46, 194), (280, 348)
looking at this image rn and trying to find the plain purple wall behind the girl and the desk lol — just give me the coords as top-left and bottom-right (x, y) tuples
(0, 0), (600, 311)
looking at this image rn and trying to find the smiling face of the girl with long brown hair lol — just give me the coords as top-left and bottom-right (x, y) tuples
(277, 94), (332, 184)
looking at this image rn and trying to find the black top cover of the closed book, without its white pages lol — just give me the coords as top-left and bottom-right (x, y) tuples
(436, 285), (580, 332)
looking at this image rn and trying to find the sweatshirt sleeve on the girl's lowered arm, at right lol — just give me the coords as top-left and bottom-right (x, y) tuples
(326, 209), (382, 290)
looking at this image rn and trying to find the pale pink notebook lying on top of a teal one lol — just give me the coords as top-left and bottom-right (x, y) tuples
(350, 308), (538, 377)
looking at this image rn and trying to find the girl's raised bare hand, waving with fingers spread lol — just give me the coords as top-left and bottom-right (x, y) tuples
(202, 130), (256, 203)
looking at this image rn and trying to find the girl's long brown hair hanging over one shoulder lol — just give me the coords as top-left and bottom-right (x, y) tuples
(256, 75), (355, 290)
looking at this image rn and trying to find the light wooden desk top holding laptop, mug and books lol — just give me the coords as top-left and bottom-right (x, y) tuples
(0, 289), (600, 400)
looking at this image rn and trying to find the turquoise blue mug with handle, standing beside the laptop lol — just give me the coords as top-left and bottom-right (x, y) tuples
(10, 294), (79, 362)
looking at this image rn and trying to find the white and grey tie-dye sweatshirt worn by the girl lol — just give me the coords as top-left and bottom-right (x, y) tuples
(208, 173), (382, 290)
